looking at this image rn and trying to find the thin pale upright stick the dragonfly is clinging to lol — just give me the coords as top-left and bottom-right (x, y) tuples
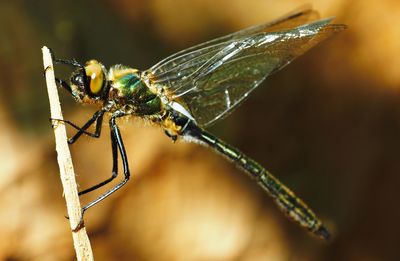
(42, 46), (93, 260)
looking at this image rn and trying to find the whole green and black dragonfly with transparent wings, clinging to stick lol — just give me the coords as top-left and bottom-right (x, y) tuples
(53, 8), (346, 239)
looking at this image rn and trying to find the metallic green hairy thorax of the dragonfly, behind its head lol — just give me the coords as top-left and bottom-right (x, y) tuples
(109, 68), (162, 115)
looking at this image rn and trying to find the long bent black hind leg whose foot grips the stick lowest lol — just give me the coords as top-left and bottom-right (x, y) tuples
(74, 116), (130, 231)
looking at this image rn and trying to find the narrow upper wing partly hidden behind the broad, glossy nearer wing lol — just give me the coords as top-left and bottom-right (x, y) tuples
(149, 7), (319, 85)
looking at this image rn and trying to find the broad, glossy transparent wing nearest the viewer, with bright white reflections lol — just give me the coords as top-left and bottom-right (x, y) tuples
(161, 19), (345, 127)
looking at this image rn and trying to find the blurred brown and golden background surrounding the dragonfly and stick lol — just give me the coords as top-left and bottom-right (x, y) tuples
(0, 0), (400, 260)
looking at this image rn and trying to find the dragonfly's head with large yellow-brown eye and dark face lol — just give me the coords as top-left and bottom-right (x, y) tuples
(70, 60), (107, 103)
